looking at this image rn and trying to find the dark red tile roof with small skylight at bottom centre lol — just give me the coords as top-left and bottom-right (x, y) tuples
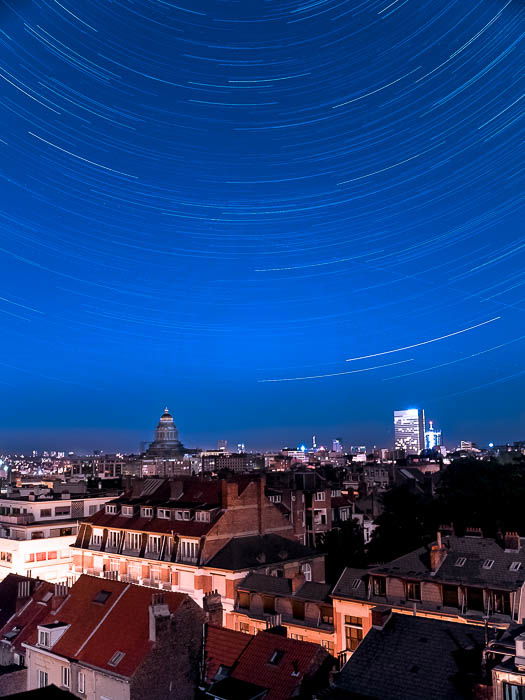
(206, 626), (329, 700)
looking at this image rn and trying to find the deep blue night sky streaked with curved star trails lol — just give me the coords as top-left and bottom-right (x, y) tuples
(0, 0), (525, 450)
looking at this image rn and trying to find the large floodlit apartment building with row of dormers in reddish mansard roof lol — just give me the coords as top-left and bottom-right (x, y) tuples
(69, 476), (324, 620)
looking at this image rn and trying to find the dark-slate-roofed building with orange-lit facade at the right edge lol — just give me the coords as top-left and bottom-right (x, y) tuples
(332, 531), (525, 650)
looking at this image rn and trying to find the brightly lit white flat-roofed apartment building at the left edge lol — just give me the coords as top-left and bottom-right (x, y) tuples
(0, 488), (115, 581)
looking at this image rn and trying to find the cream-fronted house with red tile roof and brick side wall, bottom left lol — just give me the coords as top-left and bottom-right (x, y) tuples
(21, 576), (204, 700)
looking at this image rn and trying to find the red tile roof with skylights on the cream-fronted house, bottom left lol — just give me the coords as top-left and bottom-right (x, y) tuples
(25, 575), (188, 677)
